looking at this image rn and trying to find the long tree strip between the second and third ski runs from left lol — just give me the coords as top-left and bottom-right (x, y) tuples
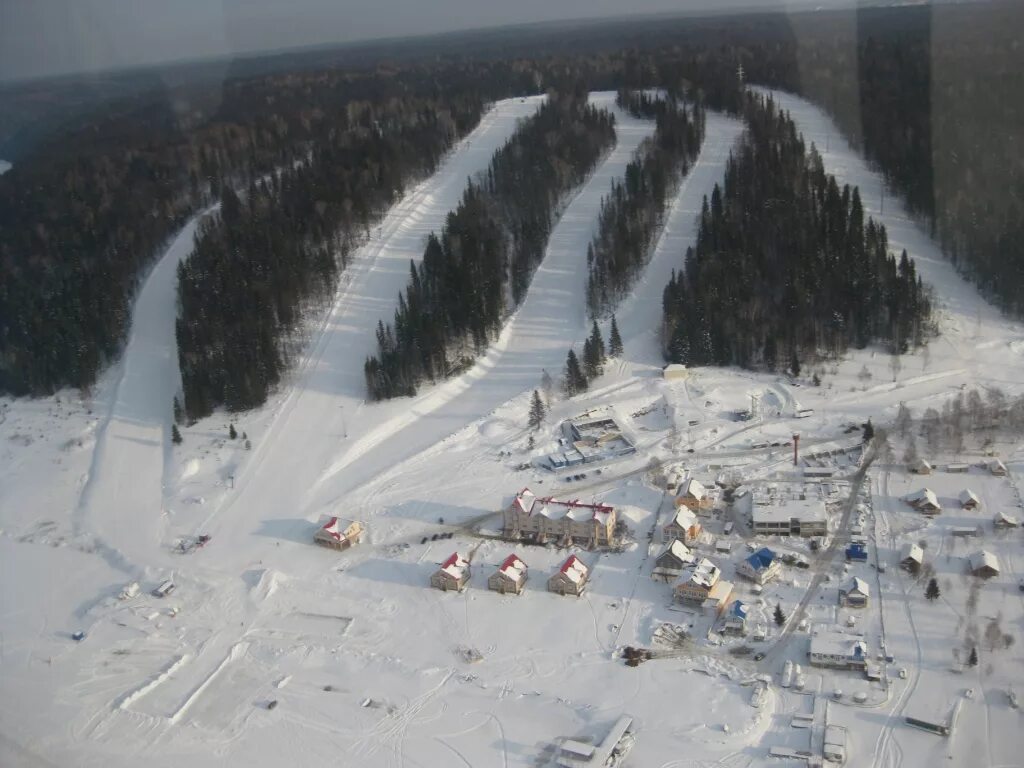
(364, 88), (615, 400)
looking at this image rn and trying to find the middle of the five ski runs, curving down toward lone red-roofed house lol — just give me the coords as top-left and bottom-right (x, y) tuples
(306, 92), (654, 513)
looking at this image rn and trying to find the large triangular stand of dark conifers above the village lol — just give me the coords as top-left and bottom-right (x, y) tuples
(663, 96), (931, 370)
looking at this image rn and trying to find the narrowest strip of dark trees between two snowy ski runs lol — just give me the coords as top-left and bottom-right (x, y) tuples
(587, 89), (705, 317)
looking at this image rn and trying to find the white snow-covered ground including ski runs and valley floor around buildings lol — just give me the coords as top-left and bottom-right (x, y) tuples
(0, 93), (1024, 768)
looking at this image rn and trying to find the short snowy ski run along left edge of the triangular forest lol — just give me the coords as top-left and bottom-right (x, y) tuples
(605, 112), (743, 366)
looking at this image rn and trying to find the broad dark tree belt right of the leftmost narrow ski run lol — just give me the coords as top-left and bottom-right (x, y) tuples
(176, 95), (483, 419)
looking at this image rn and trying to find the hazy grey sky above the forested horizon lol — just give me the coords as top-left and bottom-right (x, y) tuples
(0, 0), (786, 80)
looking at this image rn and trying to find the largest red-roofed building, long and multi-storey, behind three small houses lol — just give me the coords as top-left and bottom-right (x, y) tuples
(502, 488), (615, 548)
